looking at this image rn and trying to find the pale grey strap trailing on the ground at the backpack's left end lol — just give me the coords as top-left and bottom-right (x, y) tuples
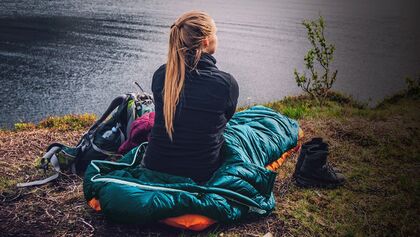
(16, 146), (61, 188)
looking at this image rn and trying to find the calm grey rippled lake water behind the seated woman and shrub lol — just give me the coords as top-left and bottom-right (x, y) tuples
(0, 0), (420, 126)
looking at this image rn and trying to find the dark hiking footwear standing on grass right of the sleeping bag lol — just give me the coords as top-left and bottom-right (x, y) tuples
(295, 145), (345, 188)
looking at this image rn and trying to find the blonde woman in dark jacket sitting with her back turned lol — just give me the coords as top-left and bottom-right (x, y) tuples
(143, 11), (239, 183)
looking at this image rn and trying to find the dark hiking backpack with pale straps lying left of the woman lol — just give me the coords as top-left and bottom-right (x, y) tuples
(17, 90), (154, 187)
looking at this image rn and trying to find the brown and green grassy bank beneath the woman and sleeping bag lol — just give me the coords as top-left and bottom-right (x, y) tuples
(0, 90), (420, 236)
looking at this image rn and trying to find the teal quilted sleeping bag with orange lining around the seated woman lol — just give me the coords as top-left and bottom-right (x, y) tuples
(83, 106), (299, 223)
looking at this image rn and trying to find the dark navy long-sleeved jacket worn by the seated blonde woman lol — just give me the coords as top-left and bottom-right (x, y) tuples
(144, 53), (239, 182)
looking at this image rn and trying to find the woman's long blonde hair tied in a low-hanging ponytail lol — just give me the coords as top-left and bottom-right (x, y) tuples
(163, 11), (215, 141)
